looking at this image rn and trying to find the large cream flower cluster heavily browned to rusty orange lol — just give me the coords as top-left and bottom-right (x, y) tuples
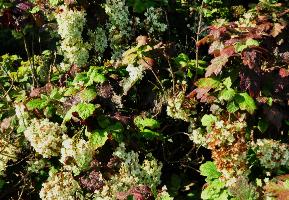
(189, 120), (250, 186)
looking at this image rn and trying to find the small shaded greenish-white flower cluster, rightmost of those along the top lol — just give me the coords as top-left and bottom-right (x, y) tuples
(144, 7), (167, 34)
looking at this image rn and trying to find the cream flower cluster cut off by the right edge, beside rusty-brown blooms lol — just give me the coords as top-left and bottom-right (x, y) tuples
(252, 139), (289, 170)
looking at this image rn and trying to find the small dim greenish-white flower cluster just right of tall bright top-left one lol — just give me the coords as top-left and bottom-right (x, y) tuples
(88, 27), (107, 54)
